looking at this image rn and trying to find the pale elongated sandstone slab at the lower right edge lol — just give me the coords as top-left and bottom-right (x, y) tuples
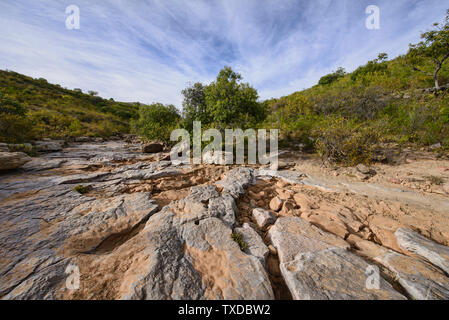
(395, 228), (449, 275)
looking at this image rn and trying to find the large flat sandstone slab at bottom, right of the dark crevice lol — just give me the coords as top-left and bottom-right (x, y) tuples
(269, 217), (405, 300)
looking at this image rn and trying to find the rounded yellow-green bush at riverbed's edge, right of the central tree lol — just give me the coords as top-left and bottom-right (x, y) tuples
(315, 118), (379, 166)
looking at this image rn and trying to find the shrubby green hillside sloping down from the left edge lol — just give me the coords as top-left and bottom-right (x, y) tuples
(0, 70), (139, 142)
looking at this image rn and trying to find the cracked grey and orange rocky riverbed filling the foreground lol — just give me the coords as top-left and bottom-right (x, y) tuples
(0, 141), (449, 299)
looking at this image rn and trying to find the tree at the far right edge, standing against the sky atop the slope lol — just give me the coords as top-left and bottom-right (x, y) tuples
(407, 10), (449, 91)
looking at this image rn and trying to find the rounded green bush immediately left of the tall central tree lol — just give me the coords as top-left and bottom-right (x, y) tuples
(131, 103), (181, 143)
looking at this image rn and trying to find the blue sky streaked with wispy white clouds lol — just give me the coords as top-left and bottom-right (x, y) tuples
(0, 0), (449, 107)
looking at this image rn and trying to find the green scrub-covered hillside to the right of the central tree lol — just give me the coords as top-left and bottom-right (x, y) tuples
(265, 54), (449, 163)
